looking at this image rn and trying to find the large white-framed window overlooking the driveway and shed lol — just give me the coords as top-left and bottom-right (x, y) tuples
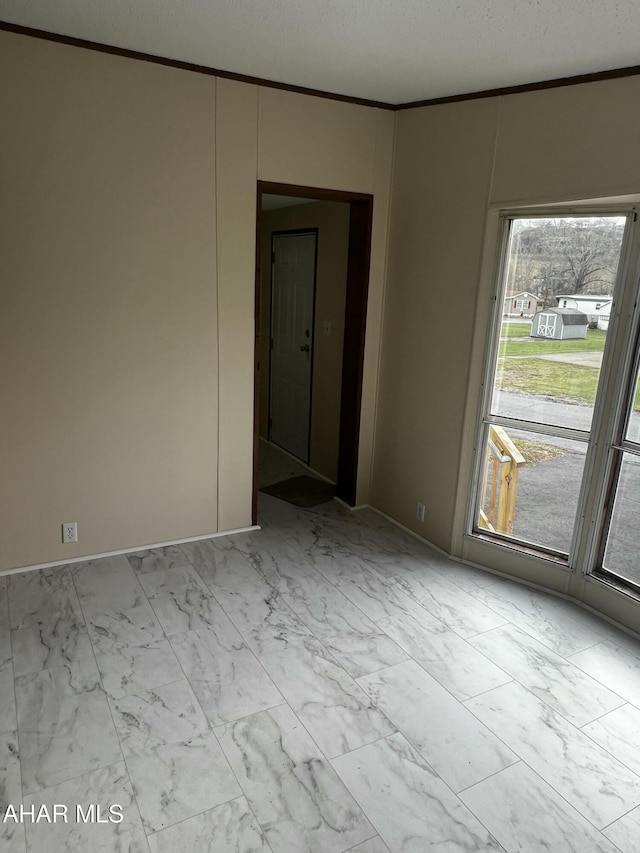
(469, 209), (640, 592)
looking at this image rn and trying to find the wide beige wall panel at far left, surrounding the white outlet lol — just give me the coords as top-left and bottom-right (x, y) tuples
(0, 33), (218, 569)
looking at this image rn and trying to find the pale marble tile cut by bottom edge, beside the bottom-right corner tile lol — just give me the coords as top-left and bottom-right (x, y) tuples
(460, 762), (615, 853)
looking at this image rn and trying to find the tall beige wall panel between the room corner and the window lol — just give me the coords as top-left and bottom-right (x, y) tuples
(372, 100), (497, 550)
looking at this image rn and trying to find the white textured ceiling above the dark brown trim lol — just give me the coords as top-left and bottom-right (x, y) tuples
(0, 0), (640, 104)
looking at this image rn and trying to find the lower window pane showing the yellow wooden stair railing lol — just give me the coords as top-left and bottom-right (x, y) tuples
(476, 425), (587, 553)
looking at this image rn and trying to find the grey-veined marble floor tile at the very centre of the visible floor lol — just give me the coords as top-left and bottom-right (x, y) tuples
(262, 638), (395, 758)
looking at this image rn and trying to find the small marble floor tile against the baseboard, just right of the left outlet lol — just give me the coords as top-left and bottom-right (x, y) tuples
(71, 556), (145, 618)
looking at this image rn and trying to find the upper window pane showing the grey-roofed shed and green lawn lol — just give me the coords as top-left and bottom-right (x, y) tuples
(491, 216), (625, 431)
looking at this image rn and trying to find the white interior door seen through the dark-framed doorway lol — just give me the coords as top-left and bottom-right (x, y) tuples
(270, 232), (317, 462)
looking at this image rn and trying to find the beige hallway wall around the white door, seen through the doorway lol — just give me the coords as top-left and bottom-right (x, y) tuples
(260, 201), (349, 482)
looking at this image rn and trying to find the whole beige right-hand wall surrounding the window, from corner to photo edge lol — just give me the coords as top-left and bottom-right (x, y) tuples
(372, 77), (640, 630)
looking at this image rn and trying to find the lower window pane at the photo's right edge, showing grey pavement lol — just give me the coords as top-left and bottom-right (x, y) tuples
(604, 453), (640, 583)
